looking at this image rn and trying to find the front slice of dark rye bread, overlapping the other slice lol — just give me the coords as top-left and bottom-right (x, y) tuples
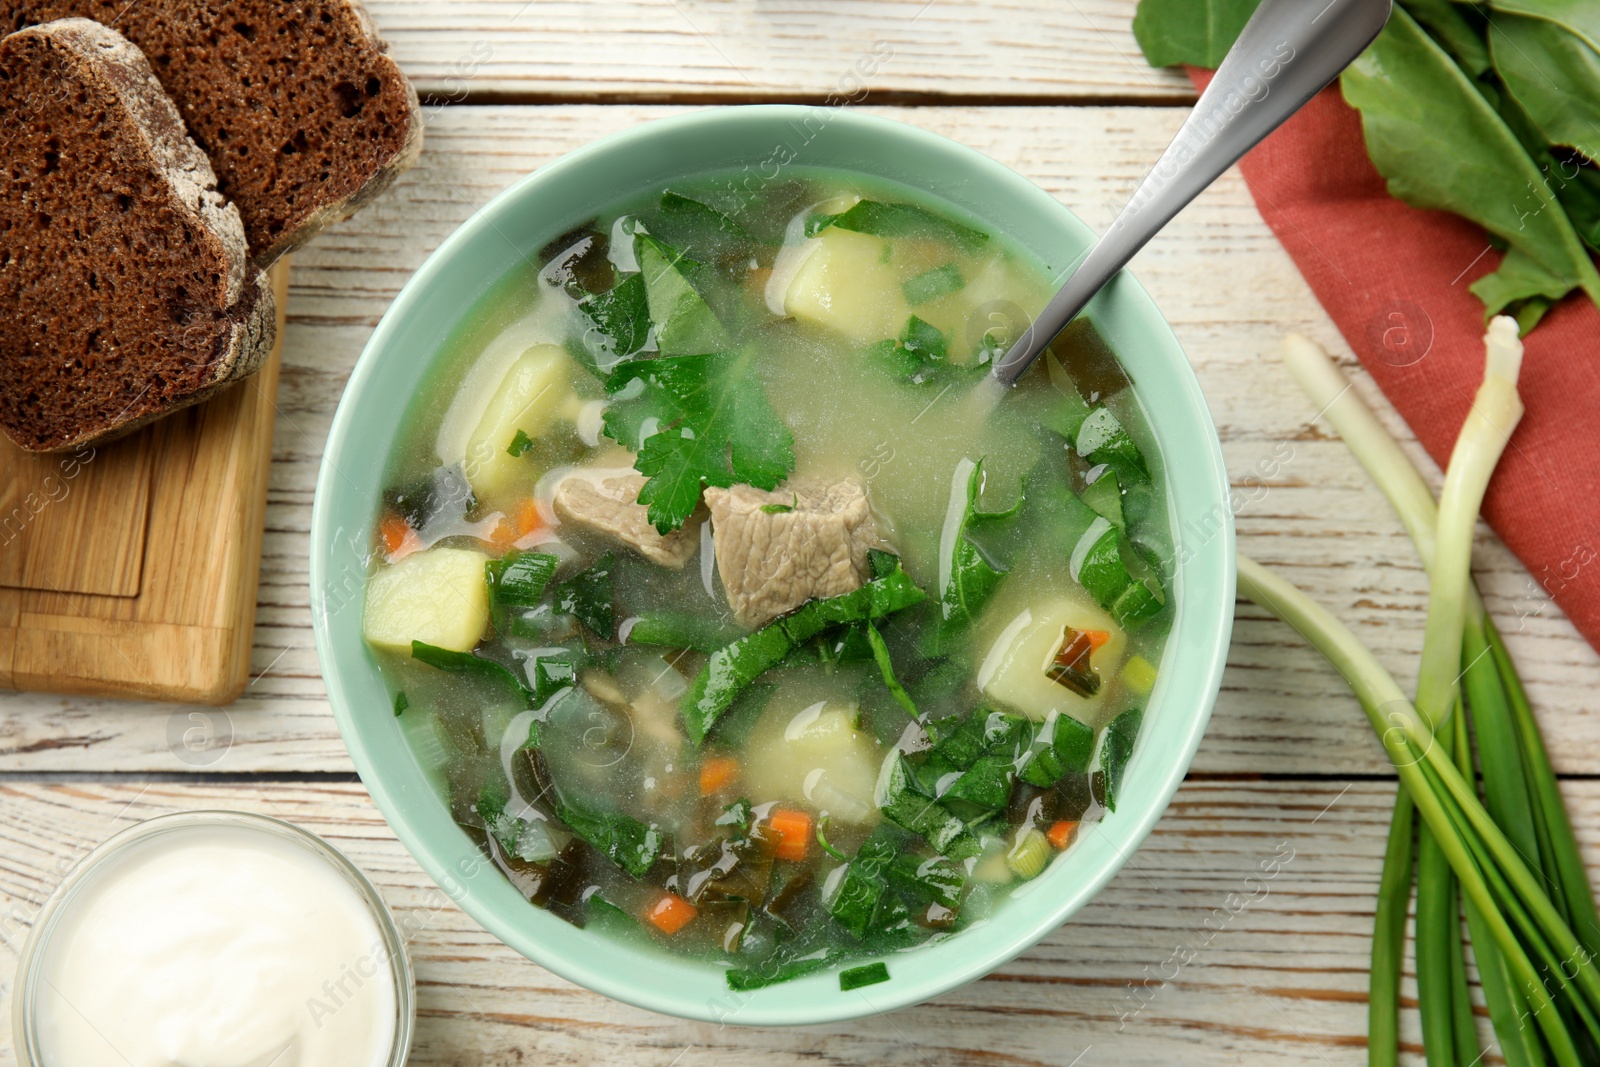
(0, 19), (274, 451)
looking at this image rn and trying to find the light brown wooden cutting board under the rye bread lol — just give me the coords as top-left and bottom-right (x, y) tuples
(0, 259), (288, 704)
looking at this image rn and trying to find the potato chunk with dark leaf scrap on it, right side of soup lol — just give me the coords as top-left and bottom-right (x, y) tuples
(978, 600), (1128, 726)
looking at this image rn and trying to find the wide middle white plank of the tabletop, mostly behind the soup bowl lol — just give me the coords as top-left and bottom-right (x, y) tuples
(0, 106), (1600, 774)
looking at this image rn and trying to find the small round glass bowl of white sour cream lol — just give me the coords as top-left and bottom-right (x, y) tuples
(13, 811), (416, 1067)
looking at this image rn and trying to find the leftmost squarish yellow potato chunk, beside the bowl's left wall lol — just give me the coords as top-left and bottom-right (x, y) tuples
(363, 549), (490, 653)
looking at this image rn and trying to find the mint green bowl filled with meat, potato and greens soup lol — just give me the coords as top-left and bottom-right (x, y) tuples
(310, 106), (1234, 1025)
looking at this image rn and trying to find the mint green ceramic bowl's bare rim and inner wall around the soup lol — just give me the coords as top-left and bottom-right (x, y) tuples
(310, 106), (1234, 1025)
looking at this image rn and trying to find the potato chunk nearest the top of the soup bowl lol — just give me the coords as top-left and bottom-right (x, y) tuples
(784, 229), (910, 344)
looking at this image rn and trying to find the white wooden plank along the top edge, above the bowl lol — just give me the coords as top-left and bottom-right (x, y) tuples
(368, 0), (1194, 102)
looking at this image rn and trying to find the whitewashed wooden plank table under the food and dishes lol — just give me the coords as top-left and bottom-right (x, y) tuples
(0, 0), (1600, 1067)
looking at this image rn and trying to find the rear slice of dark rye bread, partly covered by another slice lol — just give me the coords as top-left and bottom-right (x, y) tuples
(0, 0), (422, 267)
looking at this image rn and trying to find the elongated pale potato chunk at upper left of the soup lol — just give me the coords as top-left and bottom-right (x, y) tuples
(464, 344), (576, 498)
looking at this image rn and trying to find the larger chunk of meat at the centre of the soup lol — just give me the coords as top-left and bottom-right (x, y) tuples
(706, 480), (878, 627)
